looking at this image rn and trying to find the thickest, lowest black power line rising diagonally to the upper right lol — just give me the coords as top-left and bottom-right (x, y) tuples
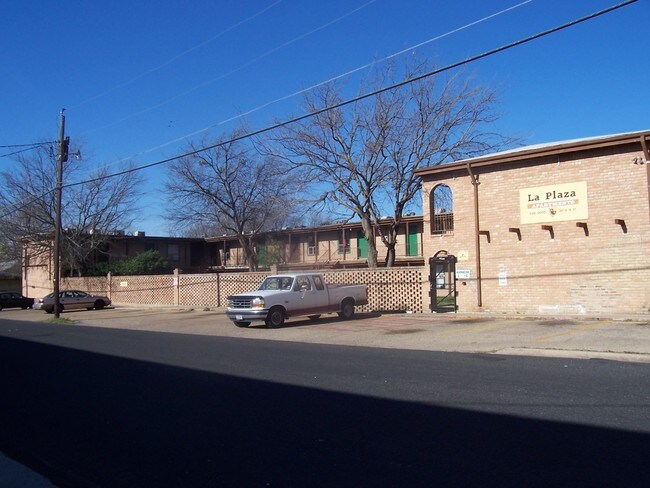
(0, 0), (638, 219)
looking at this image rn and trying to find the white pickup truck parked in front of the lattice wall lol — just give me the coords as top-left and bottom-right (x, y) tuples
(226, 273), (368, 327)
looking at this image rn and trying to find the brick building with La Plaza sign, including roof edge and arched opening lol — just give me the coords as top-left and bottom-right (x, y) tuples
(418, 131), (650, 316)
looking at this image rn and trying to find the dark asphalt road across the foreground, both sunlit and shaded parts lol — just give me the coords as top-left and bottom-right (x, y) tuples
(0, 311), (650, 487)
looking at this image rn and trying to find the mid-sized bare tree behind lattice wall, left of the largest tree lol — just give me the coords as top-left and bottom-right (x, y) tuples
(166, 129), (298, 271)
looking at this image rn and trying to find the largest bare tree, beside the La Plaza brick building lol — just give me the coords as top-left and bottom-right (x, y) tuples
(271, 61), (512, 268)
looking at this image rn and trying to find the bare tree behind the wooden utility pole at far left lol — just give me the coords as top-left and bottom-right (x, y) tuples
(0, 146), (141, 275)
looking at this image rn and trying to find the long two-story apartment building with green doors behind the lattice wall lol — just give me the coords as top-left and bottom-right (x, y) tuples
(21, 219), (424, 300)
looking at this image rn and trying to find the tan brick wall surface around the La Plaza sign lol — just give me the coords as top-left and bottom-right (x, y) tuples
(423, 145), (650, 315)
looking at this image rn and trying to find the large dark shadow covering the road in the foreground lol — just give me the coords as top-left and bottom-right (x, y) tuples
(0, 338), (650, 487)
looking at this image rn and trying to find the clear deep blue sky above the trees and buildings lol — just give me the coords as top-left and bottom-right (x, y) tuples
(0, 0), (650, 235)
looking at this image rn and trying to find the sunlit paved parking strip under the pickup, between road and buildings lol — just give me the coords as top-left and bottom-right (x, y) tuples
(0, 306), (650, 362)
